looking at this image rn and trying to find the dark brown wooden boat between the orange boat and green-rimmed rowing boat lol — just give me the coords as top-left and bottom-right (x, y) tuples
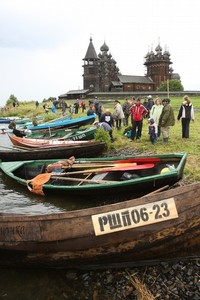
(0, 141), (105, 162)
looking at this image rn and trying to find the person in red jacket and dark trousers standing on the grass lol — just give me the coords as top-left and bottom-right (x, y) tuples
(130, 98), (148, 141)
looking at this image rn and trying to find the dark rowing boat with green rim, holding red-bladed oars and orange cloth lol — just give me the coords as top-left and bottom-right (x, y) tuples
(0, 153), (187, 201)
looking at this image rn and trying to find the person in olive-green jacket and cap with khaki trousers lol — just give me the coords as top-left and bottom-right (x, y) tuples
(159, 98), (175, 144)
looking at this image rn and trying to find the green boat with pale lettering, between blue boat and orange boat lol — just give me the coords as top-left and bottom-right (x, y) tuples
(23, 126), (97, 141)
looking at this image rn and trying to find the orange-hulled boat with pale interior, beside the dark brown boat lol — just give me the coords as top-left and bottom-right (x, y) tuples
(8, 134), (95, 149)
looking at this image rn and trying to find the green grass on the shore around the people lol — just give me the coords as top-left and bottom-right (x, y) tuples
(0, 96), (200, 181)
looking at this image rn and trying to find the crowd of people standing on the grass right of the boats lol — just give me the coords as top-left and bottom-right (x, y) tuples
(87, 95), (194, 144)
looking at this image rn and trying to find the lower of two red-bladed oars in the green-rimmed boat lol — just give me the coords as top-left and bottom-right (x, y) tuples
(57, 164), (154, 175)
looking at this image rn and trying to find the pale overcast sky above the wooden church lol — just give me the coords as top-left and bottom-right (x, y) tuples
(0, 0), (200, 106)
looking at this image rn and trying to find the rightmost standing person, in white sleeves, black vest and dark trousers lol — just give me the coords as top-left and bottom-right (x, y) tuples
(177, 95), (194, 139)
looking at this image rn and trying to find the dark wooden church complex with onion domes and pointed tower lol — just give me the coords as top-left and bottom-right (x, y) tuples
(83, 38), (180, 92)
